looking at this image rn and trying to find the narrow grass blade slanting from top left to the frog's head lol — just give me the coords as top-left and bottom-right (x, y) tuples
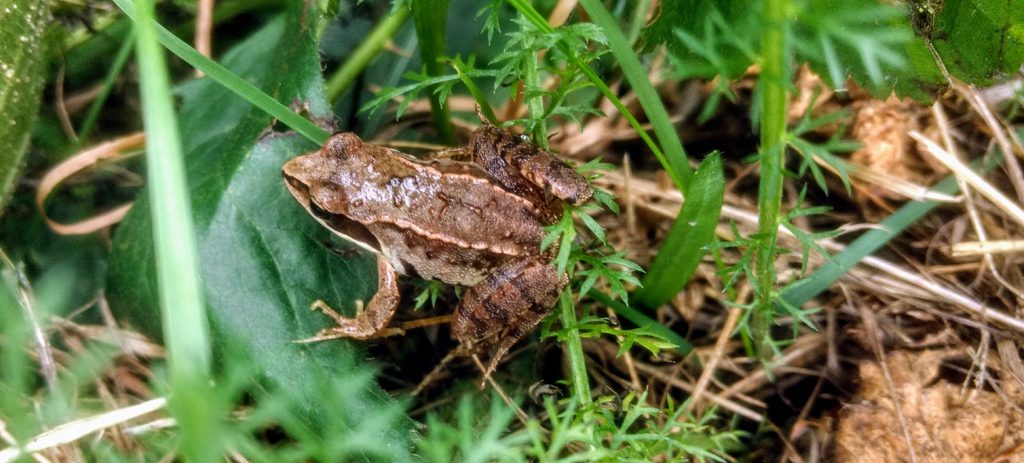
(108, 0), (331, 144)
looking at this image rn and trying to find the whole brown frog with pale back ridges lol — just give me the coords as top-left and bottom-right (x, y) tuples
(283, 125), (593, 376)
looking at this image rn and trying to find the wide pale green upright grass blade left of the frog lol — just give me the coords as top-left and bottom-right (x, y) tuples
(134, 0), (219, 461)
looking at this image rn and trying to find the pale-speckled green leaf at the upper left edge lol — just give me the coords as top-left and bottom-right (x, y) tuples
(0, 0), (50, 213)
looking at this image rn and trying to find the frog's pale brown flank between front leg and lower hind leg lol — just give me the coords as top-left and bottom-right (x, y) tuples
(367, 222), (516, 287)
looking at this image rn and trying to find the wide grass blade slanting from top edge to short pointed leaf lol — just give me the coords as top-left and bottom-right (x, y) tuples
(580, 0), (691, 191)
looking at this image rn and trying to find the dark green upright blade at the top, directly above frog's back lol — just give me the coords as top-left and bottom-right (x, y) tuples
(413, 0), (456, 145)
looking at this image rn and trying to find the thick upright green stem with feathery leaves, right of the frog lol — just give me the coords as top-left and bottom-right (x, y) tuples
(751, 0), (790, 362)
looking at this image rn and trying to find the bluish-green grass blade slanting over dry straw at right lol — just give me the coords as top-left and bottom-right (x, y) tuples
(781, 156), (1002, 307)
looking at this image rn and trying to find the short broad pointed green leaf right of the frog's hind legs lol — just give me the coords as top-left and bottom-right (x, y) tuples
(635, 153), (725, 308)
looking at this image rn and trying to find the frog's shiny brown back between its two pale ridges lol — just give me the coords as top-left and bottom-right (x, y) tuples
(348, 152), (544, 254)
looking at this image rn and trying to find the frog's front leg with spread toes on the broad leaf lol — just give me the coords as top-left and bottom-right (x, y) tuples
(301, 256), (402, 342)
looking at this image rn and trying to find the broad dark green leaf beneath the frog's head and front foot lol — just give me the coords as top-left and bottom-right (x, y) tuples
(108, 9), (409, 461)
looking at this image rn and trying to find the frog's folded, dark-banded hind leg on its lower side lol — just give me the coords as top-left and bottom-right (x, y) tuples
(452, 257), (567, 378)
